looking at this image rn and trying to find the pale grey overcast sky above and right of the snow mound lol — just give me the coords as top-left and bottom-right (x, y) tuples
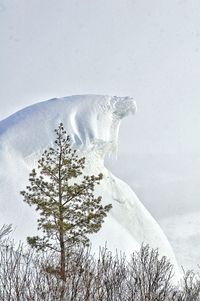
(0, 0), (200, 215)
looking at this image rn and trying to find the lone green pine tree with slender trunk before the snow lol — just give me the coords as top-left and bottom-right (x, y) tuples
(21, 123), (112, 280)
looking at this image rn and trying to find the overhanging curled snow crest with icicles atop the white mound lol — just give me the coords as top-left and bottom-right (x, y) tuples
(0, 95), (136, 156)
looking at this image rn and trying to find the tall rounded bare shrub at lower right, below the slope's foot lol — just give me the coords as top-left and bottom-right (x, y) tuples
(127, 245), (173, 301)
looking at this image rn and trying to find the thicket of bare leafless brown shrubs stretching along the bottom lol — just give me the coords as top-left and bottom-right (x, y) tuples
(0, 241), (200, 301)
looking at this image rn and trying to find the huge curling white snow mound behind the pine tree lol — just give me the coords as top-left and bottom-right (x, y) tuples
(0, 95), (176, 265)
